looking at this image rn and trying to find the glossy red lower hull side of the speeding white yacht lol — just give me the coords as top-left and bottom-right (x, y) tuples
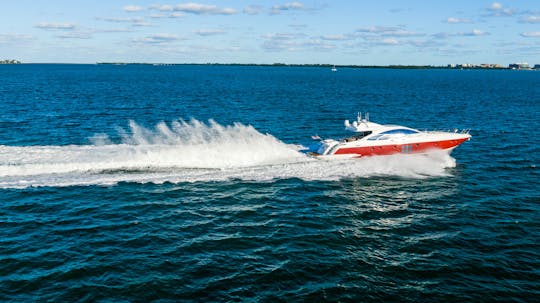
(334, 138), (468, 156)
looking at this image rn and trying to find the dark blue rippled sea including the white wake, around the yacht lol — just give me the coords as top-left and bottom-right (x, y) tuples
(0, 64), (540, 302)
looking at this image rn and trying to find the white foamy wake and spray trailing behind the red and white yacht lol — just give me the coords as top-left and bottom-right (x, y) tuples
(0, 120), (455, 188)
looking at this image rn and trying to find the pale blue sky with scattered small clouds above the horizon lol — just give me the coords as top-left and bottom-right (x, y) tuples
(0, 0), (540, 65)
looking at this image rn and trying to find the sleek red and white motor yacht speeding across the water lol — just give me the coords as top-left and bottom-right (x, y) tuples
(308, 113), (471, 157)
